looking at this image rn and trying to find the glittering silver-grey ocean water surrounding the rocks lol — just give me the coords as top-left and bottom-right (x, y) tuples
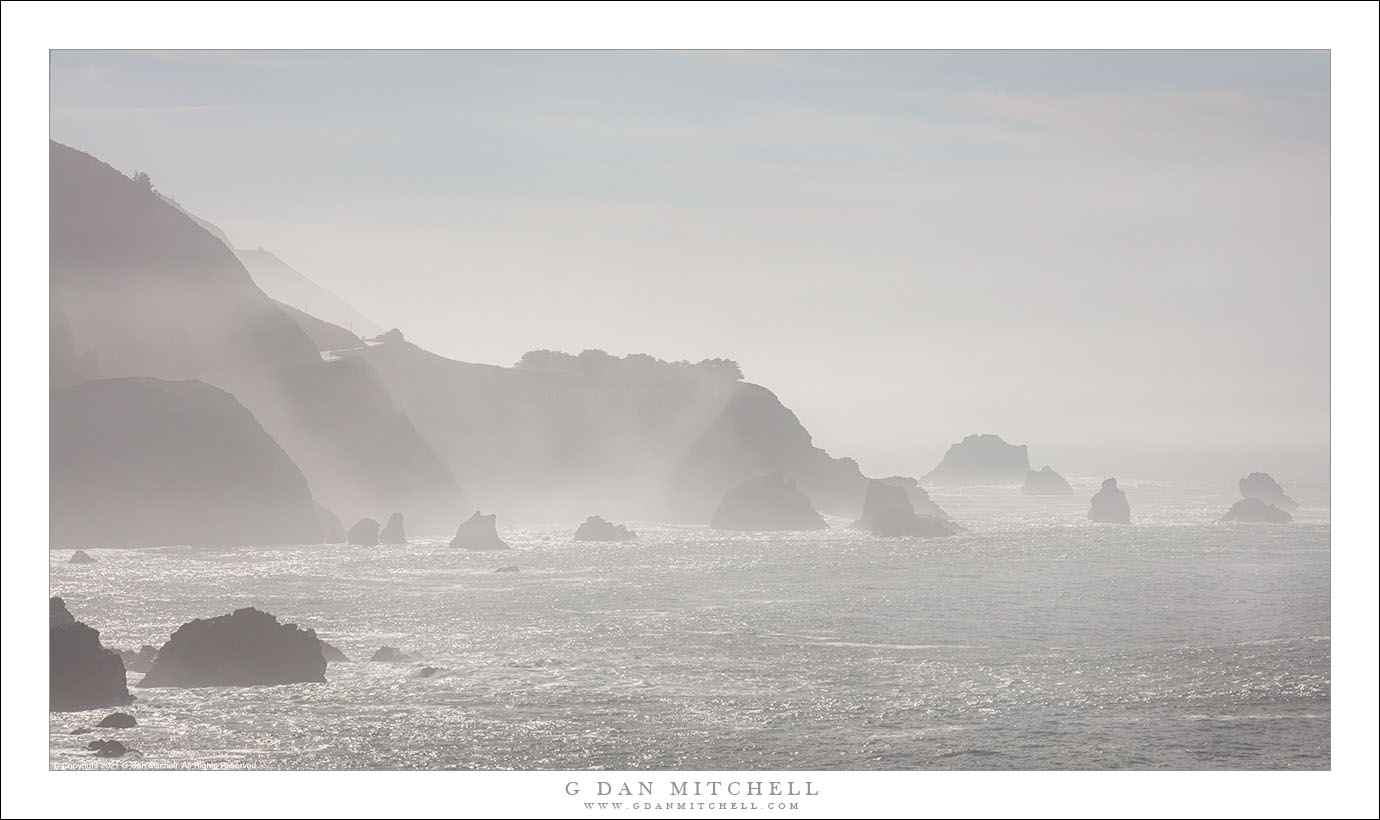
(51, 478), (1330, 770)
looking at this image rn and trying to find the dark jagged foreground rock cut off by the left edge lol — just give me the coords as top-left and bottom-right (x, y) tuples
(48, 598), (134, 711)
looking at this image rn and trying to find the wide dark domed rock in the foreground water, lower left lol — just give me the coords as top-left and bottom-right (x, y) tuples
(138, 607), (326, 687)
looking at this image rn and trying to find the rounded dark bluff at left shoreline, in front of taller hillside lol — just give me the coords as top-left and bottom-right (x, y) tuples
(50, 378), (320, 547)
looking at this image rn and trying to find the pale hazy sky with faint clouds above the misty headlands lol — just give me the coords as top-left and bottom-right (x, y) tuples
(51, 51), (1330, 475)
